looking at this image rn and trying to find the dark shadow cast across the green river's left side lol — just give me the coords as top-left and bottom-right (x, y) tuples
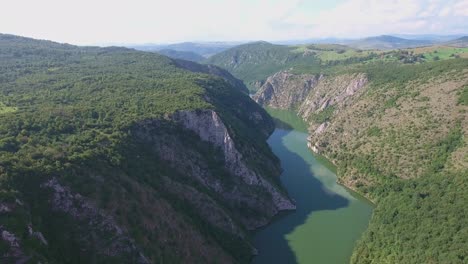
(252, 129), (349, 264)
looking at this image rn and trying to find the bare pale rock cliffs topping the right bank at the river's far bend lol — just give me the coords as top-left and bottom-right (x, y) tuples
(253, 72), (368, 153)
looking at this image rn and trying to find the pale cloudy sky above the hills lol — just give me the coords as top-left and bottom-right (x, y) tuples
(0, 0), (468, 45)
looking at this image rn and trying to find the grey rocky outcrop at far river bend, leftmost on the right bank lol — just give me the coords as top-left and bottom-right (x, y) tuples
(253, 71), (323, 109)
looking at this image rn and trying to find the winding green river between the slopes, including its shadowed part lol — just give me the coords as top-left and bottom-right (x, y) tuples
(252, 110), (373, 264)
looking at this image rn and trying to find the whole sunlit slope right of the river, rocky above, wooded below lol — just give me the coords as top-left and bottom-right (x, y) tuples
(254, 59), (468, 263)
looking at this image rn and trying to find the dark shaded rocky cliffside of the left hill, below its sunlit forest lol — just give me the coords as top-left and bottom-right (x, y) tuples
(0, 106), (295, 263)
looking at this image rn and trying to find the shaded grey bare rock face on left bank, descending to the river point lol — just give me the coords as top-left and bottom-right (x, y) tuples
(136, 110), (295, 229)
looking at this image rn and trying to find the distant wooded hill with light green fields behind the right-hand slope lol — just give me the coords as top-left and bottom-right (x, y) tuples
(206, 42), (468, 92)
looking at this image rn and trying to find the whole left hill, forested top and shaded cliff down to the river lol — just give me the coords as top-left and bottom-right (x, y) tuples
(0, 35), (294, 263)
